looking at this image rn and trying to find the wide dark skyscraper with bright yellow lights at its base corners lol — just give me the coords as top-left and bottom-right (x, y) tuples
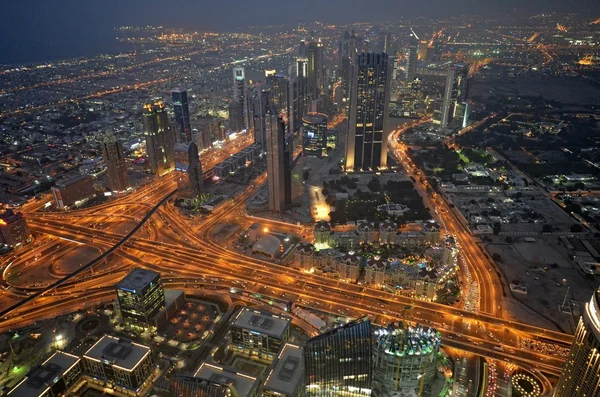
(346, 52), (393, 172)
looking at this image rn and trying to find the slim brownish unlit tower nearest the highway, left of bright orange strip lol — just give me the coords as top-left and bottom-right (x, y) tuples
(265, 107), (291, 214)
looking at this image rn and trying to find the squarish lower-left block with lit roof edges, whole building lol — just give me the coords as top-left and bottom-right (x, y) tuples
(82, 335), (156, 396)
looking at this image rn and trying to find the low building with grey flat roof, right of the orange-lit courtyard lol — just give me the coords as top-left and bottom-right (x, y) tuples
(230, 307), (292, 360)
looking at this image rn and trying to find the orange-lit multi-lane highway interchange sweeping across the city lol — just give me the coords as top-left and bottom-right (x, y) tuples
(0, 123), (572, 386)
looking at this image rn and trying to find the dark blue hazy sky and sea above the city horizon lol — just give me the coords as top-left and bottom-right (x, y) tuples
(0, 0), (600, 63)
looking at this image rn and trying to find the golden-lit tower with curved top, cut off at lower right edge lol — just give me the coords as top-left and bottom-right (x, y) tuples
(554, 289), (600, 397)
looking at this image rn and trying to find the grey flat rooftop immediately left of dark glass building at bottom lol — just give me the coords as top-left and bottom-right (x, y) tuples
(265, 343), (302, 397)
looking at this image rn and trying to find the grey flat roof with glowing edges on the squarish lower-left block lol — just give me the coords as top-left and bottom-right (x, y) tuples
(83, 335), (150, 371)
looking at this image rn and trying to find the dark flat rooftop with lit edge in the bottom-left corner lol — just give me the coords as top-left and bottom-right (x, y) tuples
(8, 351), (80, 397)
